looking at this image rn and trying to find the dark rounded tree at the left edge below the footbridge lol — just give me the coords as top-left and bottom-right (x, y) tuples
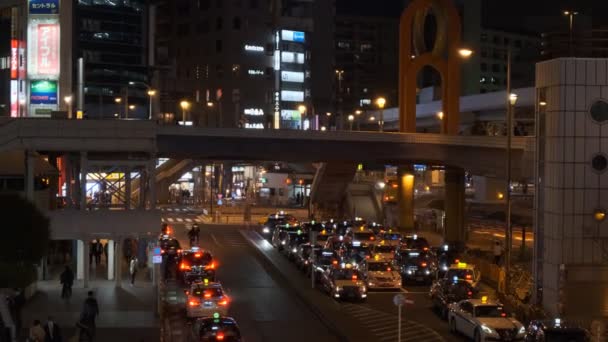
(0, 194), (51, 265)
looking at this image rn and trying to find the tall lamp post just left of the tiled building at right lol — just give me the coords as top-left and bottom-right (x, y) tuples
(505, 47), (525, 293)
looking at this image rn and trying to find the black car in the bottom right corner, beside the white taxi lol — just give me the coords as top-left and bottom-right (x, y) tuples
(526, 318), (591, 342)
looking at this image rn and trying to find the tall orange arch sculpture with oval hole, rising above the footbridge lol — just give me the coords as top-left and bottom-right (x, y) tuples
(399, 0), (461, 135)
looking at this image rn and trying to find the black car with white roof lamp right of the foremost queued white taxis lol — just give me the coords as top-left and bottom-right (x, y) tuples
(396, 250), (437, 283)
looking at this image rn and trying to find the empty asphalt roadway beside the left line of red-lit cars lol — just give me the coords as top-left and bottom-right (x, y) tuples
(164, 224), (337, 342)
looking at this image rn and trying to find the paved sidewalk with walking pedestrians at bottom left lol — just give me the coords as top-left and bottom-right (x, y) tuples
(22, 272), (160, 342)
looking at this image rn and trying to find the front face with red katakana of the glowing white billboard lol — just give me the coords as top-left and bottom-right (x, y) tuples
(36, 24), (59, 75)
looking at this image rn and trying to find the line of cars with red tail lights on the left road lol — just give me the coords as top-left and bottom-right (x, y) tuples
(159, 225), (242, 342)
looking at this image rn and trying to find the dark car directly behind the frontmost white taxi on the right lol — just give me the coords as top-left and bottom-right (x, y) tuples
(429, 279), (475, 320)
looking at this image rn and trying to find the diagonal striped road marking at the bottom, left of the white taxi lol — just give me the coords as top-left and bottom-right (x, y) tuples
(341, 303), (445, 342)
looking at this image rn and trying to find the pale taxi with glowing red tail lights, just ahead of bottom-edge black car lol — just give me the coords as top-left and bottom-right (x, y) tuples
(184, 279), (230, 318)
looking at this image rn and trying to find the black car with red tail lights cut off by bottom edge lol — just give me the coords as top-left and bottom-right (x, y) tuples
(188, 314), (242, 342)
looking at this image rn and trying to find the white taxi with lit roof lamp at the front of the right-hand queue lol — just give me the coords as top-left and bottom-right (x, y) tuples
(448, 296), (526, 342)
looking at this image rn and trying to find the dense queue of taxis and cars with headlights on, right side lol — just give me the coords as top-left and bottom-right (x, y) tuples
(260, 213), (588, 342)
